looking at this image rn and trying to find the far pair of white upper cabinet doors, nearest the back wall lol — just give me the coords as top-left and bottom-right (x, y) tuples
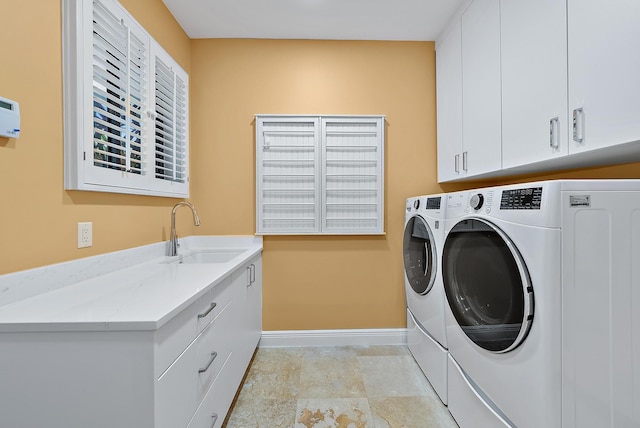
(436, 0), (501, 182)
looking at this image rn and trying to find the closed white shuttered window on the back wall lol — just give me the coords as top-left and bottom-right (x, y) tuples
(256, 115), (384, 234)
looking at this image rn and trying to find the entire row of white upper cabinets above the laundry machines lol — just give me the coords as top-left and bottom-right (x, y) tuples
(436, 0), (640, 182)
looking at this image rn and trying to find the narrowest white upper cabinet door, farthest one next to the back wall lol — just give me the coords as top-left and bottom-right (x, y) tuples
(436, 17), (462, 182)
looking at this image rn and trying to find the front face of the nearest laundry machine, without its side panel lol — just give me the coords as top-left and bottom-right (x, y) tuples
(442, 184), (561, 428)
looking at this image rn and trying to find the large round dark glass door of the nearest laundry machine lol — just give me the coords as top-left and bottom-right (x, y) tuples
(442, 219), (533, 352)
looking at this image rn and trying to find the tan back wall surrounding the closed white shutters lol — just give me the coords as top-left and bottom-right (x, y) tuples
(191, 40), (439, 330)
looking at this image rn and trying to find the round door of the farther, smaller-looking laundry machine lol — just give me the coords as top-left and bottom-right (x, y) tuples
(402, 215), (437, 294)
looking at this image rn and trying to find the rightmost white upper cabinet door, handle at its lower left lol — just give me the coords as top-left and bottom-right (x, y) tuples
(568, 0), (640, 153)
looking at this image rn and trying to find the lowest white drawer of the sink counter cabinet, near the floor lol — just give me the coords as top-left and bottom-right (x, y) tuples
(187, 353), (238, 428)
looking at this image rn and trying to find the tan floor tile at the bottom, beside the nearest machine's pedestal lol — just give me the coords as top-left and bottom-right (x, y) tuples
(369, 397), (458, 428)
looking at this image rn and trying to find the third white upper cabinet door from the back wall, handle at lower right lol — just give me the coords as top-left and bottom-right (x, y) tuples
(500, 0), (568, 168)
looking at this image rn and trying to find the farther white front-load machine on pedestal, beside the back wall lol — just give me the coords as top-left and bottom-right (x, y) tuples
(403, 194), (448, 404)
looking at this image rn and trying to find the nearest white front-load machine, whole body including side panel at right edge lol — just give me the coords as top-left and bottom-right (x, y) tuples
(442, 180), (640, 428)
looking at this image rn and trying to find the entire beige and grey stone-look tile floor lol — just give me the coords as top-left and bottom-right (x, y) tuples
(224, 346), (457, 428)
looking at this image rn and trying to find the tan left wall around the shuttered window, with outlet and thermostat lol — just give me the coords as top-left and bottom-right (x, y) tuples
(0, 0), (192, 274)
